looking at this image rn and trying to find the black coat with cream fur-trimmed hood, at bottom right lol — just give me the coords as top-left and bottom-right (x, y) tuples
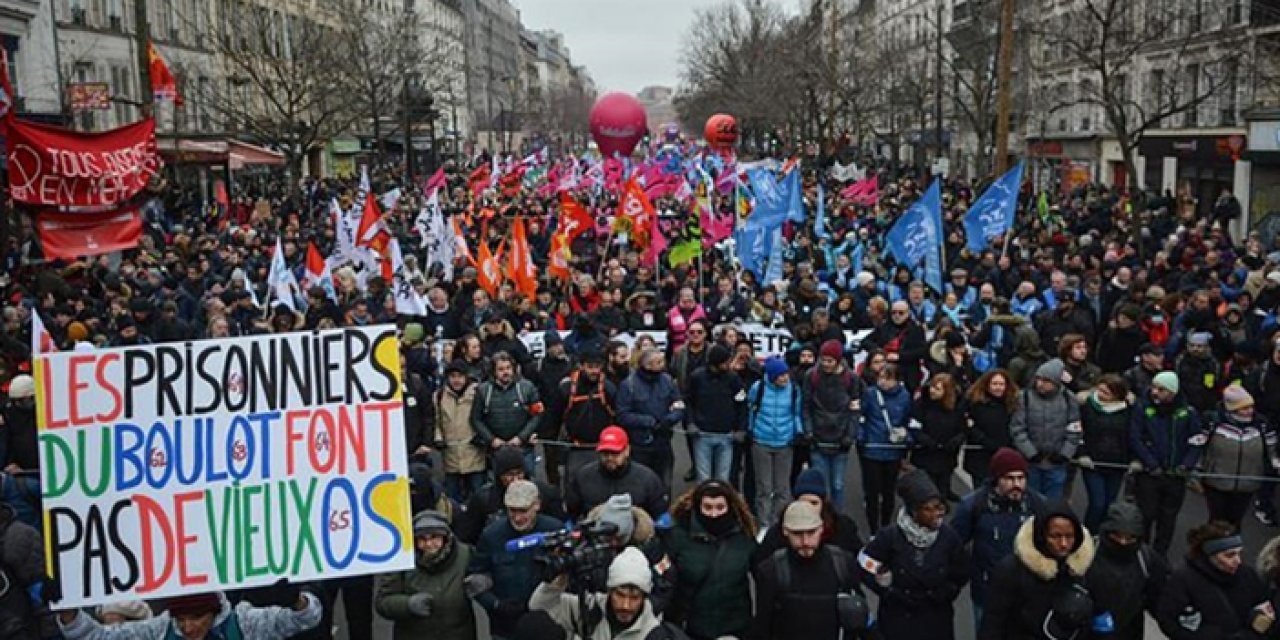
(978, 504), (1096, 640)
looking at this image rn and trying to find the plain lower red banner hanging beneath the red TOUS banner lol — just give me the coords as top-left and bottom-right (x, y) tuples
(36, 207), (142, 260)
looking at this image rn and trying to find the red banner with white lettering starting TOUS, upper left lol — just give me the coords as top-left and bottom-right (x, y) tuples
(9, 118), (160, 207)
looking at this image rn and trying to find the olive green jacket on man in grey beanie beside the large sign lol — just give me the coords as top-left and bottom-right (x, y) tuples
(374, 540), (476, 640)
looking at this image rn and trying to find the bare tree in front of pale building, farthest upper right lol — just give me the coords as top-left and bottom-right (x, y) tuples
(1036, 0), (1249, 198)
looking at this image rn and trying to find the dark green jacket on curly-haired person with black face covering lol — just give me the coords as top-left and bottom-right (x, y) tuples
(667, 512), (755, 637)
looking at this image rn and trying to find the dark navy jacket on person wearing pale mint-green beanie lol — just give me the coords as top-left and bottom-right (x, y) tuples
(1129, 392), (1204, 471)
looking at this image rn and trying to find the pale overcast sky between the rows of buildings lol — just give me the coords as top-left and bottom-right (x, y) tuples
(512, 0), (801, 93)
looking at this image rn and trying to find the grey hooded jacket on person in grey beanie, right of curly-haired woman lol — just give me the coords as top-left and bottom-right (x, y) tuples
(1009, 358), (1084, 466)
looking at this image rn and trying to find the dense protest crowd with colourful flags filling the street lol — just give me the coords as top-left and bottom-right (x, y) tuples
(0, 124), (1280, 640)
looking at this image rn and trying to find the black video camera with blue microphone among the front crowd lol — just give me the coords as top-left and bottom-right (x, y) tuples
(507, 521), (618, 586)
